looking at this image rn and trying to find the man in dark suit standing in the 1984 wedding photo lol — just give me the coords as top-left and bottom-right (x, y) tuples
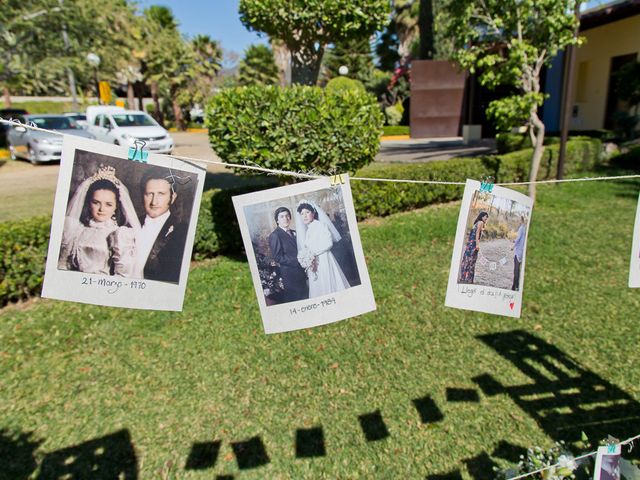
(269, 207), (309, 303)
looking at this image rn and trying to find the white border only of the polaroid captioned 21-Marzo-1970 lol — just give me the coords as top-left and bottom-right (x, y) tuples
(42, 136), (206, 311)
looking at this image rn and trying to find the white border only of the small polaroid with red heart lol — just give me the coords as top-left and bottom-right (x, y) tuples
(445, 179), (533, 318)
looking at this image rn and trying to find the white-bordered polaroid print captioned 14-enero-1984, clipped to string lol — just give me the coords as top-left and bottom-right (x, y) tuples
(233, 175), (376, 333)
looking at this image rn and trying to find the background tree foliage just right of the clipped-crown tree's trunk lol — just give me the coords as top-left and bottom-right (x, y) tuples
(323, 38), (373, 83)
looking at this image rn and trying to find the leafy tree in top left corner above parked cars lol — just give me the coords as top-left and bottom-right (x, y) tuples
(0, 0), (140, 102)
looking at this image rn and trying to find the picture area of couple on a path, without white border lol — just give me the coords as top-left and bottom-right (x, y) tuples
(458, 190), (531, 291)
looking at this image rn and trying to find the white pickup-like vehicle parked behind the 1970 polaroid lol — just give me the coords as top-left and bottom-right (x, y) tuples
(87, 106), (174, 153)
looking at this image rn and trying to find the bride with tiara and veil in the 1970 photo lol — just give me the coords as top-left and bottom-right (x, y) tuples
(58, 165), (141, 278)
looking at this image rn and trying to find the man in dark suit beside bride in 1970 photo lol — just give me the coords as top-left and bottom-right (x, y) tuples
(137, 168), (188, 283)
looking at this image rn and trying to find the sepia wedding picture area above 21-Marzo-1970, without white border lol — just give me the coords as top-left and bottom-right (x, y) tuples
(58, 149), (198, 284)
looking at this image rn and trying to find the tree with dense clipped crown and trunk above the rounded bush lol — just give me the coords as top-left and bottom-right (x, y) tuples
(240, 0), (389, 85)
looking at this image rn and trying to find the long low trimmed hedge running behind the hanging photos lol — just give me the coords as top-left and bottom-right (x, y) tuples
(0, 139), (600, 306)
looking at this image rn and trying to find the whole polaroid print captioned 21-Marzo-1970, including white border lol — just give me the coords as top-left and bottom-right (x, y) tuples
(42, 136), (206, 311)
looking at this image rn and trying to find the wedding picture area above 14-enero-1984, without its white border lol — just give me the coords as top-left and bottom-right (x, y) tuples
(245, 187), (361, 306)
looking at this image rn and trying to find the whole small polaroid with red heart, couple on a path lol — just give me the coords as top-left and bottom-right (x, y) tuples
(445, 180), (533, 317)
